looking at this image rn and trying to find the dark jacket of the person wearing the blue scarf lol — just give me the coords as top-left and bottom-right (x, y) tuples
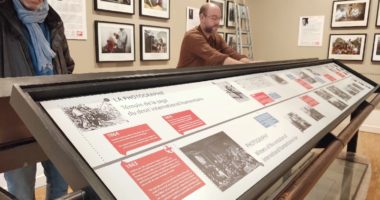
(0, 0), (74, 77)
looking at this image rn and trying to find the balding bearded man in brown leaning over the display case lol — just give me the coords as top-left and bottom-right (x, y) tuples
(177, 3), (250, 68)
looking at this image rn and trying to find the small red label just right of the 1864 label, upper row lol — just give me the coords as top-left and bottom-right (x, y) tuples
(163, 110), (205, 134)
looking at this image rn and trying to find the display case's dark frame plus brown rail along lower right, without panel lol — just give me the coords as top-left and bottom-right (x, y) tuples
(5, 60), (380, 199)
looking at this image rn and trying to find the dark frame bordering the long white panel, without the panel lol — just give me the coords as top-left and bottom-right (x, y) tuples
(11, 59), (379, 199)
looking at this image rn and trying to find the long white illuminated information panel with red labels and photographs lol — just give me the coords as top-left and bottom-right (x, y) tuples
(41, 63), (373, 200)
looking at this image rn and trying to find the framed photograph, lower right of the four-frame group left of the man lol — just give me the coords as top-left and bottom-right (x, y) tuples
(140, 25), (170, 61)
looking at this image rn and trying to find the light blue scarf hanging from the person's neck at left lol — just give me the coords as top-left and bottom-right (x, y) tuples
(13, 0), (55, 75)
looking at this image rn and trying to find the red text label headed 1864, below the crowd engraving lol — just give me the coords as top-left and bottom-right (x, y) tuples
(104, 124), (161, 155)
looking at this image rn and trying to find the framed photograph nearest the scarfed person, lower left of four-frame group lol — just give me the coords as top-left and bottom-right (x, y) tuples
(95, 21), (135, 62)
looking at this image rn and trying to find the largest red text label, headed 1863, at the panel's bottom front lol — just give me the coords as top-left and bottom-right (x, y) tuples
(121, 148), (205, 199)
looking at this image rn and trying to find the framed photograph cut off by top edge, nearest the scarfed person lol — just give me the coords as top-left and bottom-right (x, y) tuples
(95, 0), (135, 14)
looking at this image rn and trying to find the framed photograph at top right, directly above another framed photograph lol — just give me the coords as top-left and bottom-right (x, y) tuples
(331, 0), (370, 28)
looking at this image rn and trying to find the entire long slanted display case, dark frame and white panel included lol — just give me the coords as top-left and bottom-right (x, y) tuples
(7, 60), (379, 199)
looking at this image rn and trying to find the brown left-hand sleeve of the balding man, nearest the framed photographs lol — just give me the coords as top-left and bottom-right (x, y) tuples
(185, 35), (228, 66)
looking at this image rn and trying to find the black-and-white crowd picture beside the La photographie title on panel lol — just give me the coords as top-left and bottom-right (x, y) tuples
(63, 98), (126, 131)
